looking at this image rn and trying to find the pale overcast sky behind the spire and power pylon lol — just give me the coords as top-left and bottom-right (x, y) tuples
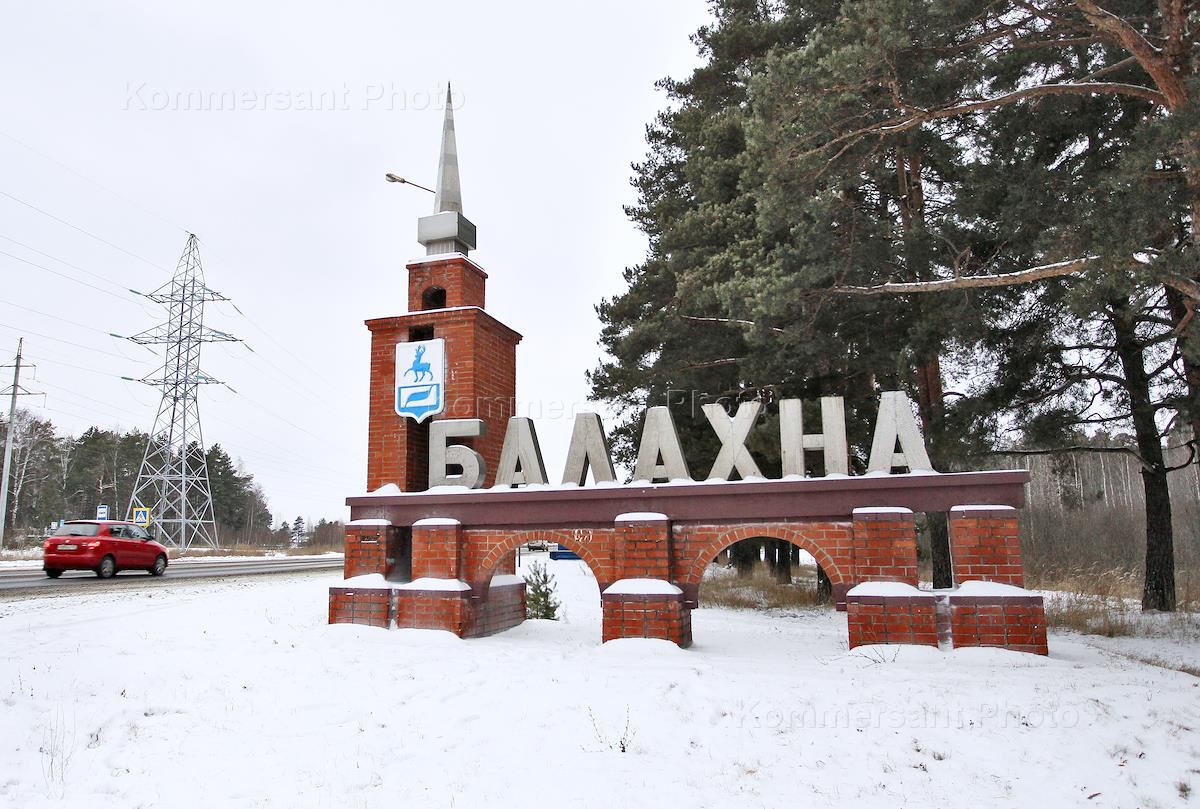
(0, 0), (707, 520)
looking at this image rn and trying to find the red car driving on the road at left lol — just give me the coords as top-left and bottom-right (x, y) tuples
(42, 520), (167, 579)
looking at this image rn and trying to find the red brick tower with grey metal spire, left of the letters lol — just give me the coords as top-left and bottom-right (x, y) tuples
(366, 89), (521, 492)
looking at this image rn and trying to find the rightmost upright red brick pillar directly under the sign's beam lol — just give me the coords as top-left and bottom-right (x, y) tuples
(950, 505), (1025, 587)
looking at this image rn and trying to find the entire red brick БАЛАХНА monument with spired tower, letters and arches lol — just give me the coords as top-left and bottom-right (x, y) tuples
(329, 91), (1046, 654)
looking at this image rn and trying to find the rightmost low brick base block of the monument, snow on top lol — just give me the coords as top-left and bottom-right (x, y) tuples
(947, 594), (1049, 654)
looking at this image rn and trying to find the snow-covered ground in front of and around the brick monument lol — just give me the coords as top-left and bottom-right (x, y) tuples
(0, 555), (1200, 809)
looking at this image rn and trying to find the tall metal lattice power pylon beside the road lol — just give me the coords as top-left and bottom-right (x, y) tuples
(126, 234), (238, 549)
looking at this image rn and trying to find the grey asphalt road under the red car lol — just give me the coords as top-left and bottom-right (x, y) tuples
(0, 556), (342, 594)
